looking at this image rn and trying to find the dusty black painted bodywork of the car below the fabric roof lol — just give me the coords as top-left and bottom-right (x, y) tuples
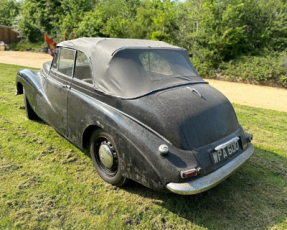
(16, 38), (254, 194)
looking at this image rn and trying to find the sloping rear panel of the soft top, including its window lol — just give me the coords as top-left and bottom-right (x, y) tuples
(99, 48), (203, 98)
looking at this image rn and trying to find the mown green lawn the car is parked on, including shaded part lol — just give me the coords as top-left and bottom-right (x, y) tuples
(0, 64), (287, 230)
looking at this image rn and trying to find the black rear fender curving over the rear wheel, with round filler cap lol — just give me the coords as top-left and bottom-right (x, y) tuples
(68, 91), (200, 191)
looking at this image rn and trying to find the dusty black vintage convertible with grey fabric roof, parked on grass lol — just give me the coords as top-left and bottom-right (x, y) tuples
(16, 38), (254, 194)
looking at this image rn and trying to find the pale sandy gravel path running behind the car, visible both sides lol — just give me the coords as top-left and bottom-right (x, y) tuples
(0, 51), (287, 112)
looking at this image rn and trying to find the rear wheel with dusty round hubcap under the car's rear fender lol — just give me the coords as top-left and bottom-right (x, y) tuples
(90, 129), (128, 186)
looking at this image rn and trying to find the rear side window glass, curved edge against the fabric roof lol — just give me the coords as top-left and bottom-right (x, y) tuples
(74, 51), (93, 84)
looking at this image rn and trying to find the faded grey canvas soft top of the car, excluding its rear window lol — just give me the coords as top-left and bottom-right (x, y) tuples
(57, 38), (202, 98)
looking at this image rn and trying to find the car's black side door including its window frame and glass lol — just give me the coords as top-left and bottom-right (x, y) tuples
(42, 48), (76, 136)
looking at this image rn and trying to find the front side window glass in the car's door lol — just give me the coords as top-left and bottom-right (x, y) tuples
(58, 48), (76, 77)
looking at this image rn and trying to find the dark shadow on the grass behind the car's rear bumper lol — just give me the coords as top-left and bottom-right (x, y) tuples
(123, 148), (287, 229)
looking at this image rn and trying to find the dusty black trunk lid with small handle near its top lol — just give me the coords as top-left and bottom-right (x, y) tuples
(157, 84), (239, 150)
